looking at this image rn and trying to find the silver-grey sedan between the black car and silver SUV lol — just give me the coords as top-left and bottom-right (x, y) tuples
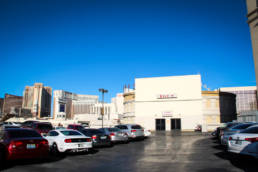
(99, 128), (129, 143)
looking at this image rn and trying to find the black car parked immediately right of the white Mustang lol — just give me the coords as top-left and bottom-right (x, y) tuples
(81, 129), (112, 147)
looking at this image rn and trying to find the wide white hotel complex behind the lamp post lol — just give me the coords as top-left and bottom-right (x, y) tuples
(53, 90), (114, 128)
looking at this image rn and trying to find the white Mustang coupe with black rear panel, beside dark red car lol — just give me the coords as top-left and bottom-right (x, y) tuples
(45, 129), (92, 153)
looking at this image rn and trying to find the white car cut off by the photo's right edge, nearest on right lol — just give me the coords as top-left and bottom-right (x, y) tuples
(228, 125), (258, 158)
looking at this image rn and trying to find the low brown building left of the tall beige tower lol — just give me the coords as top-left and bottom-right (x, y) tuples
(2, 94), (23, 115)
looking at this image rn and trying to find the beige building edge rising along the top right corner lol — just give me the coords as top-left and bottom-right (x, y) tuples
(246, 0), (258, 93)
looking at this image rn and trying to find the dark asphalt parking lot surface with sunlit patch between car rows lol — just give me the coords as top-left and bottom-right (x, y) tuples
(4, 132), (258, 172)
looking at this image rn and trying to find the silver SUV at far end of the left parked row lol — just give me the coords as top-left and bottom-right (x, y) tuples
(115, 124), (144, 139)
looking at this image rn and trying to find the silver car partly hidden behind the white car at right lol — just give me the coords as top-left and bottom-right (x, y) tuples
(220, 123), (257, 146)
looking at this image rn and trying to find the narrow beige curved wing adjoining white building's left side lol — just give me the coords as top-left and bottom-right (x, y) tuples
(120, 88), (135, 124)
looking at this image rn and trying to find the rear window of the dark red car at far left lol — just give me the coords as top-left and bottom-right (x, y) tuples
(8, 130), (41, 138)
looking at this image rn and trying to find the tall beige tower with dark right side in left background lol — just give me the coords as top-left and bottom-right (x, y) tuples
(22, 83), (52, 118)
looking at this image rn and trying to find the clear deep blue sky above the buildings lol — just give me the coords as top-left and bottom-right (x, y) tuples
(0, 0), (256, 101)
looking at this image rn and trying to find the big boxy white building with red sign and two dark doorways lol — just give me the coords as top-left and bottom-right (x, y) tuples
(135, 75), (203, 131)
